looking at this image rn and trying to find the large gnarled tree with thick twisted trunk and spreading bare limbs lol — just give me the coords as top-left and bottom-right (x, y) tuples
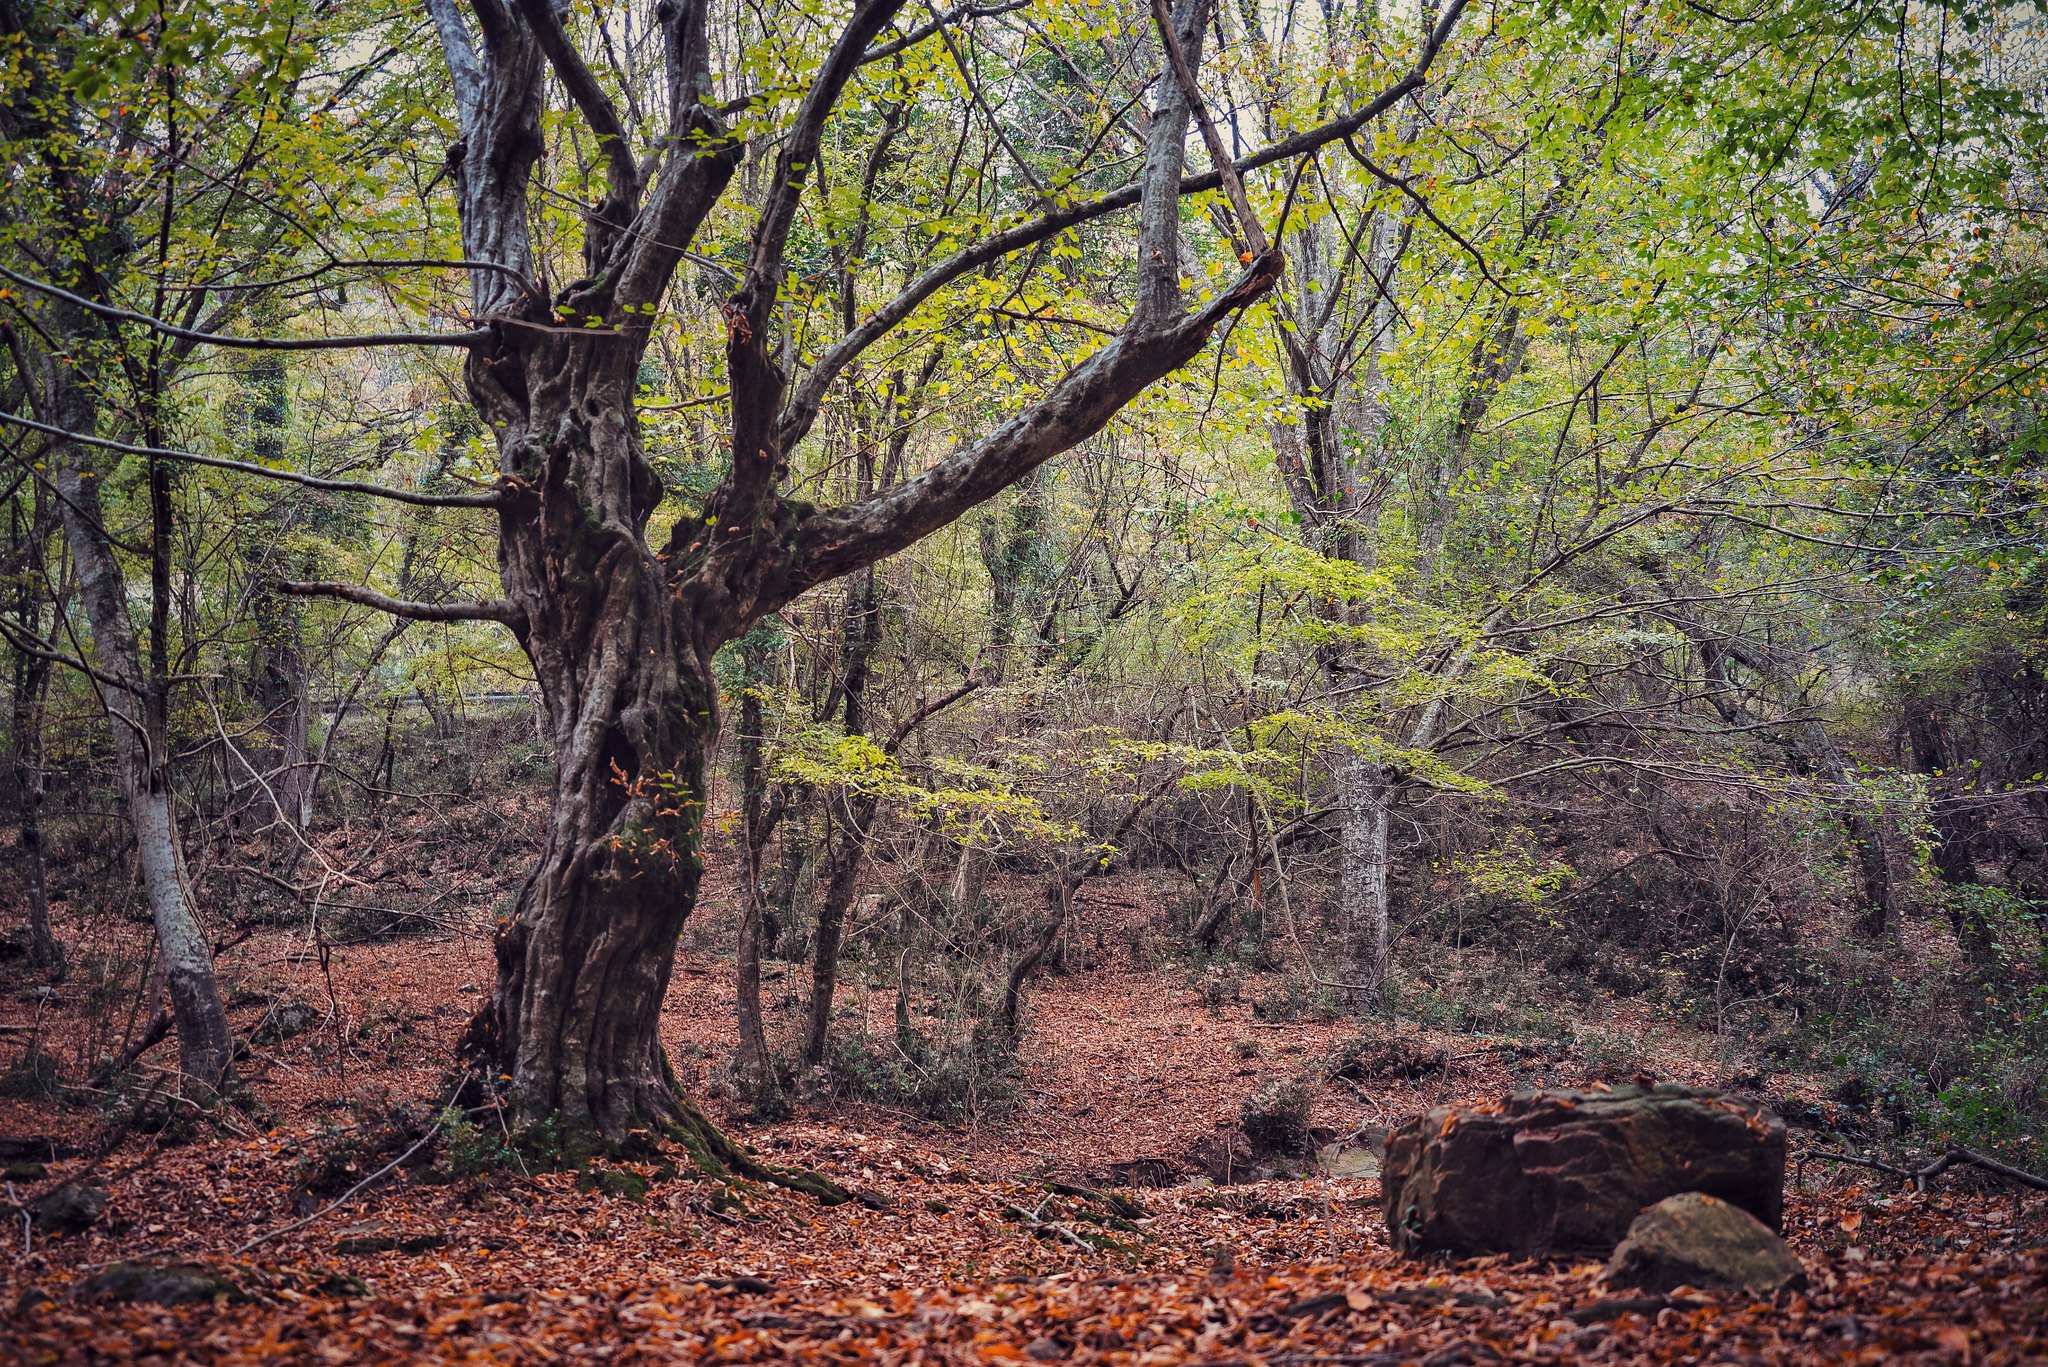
(272, 0), (1460, 1160)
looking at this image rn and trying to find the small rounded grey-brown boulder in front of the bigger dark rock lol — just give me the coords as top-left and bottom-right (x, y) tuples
(1608, 1191), (1806, 1295)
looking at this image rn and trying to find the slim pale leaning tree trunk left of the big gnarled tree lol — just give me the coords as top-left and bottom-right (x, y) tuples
(47, 361), (233, 1099)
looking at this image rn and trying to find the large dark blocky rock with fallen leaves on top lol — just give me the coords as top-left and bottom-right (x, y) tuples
(1380, 1082), (1786, 1256)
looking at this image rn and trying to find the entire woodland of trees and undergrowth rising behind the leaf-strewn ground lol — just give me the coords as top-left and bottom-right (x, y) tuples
(0, 0), (2048, 1162)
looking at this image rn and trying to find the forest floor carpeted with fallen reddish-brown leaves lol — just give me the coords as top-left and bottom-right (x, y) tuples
(0, 879), (2048, 1367)
